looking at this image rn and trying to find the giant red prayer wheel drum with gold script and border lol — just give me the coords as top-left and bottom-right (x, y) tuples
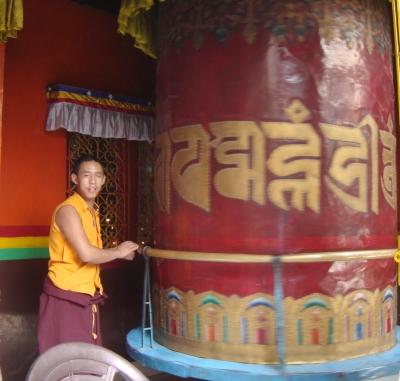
(150, 0), (397, 364)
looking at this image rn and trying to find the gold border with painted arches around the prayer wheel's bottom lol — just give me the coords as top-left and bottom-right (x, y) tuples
(153, 285), (397, 364)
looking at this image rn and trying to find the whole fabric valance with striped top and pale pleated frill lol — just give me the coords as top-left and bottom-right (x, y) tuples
(46, 84), (154, 142)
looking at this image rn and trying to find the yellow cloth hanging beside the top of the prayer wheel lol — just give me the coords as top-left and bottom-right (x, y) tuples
(118, 0), (165, 58)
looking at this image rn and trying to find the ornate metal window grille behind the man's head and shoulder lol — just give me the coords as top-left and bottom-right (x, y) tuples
(67, 133), (128, 248)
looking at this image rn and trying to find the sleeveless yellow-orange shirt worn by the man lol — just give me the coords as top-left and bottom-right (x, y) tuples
(48, 193), (103, 296)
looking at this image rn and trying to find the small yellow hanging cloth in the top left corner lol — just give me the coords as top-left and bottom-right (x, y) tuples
(0, 0), (24, 43)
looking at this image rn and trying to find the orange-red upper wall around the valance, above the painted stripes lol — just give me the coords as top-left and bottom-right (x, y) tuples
(0, 0), (155, 226)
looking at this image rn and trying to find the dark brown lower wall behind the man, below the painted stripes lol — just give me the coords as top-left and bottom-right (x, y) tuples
(0, 258), (143, 381)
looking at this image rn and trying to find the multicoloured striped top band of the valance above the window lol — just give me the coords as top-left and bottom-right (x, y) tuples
(46, 85), (155, 115)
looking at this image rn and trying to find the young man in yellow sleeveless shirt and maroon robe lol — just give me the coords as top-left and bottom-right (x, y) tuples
(38, 155), (138, 353)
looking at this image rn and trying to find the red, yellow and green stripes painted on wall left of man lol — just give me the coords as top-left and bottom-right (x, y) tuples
(0, 226), (49, 261)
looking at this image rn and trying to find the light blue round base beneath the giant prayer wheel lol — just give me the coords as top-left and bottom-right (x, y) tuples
(126, 327), (400, 381)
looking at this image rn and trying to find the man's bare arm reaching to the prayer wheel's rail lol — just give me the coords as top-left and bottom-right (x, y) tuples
(56, 205), (138, 264)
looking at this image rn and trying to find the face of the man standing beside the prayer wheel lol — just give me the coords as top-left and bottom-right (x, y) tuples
(71, 161), (106, 202)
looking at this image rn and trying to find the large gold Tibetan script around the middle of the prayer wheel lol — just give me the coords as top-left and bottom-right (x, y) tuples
(155, 100), (397, 214)
